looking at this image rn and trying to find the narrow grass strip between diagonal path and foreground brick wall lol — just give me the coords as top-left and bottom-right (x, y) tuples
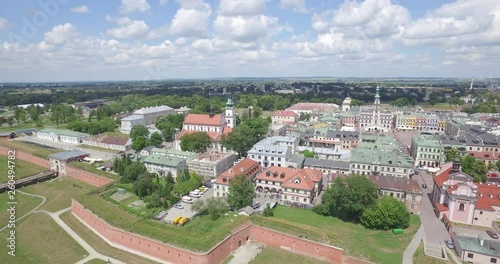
(61, 212), (156, 264)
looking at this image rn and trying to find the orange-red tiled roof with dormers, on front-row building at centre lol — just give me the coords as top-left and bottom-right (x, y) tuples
(256, 166), (323, 190)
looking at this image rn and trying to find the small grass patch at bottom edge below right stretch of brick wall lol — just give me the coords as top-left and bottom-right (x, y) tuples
(249, 247), (328, 264)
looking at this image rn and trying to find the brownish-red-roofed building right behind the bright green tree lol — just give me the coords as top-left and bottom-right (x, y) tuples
(368, 175), (423, 215)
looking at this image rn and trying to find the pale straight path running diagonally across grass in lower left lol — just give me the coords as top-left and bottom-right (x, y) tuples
(37, 207), (125, 264)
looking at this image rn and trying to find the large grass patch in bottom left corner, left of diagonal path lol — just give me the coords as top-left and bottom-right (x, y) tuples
(0, 213), (88, 264)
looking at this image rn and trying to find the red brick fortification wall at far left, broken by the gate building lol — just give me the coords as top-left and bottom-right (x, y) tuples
(0, 147), (113, 187)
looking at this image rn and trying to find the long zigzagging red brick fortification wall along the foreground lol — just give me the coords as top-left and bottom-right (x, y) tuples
(71, 200), (343, 264)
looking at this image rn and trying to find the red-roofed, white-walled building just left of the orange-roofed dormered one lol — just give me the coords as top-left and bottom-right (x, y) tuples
(214, 158), (261, 197)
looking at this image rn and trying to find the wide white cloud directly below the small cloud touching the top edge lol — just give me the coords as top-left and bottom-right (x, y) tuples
(214, 15), (281, 43)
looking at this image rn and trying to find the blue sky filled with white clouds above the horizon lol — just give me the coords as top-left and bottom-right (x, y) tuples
(0, 0), (500, 82)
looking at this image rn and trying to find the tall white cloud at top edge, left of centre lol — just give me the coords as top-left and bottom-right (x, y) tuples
(170, 0), (212, 38)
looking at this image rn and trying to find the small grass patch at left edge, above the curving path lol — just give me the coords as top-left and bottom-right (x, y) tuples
(0, 189), (42, 227)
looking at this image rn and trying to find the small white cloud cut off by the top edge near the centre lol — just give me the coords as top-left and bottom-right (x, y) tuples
(219, 0), (269, 16)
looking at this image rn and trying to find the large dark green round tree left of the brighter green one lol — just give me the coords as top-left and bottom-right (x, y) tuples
(315, 175), (378, 221)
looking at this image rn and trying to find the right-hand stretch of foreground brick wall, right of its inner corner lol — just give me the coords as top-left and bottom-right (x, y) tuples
(252, 225), (344, 264)
